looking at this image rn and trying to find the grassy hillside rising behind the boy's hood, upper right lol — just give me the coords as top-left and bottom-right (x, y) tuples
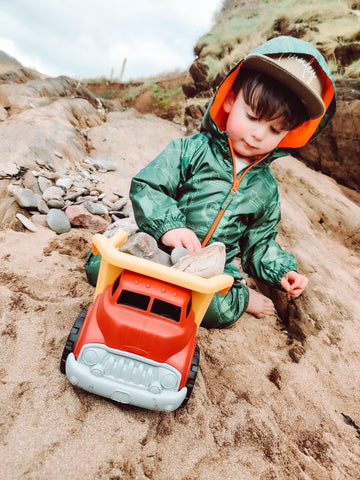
(194, 0), (360, 79)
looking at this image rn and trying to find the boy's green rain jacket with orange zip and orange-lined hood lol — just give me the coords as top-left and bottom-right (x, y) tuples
(130, 37), (336, 323)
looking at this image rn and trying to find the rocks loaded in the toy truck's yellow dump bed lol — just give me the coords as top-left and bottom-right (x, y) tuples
(120, 232), (226, 278)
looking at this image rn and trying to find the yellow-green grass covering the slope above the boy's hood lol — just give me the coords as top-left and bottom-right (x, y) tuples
(195, 0), (359, 79)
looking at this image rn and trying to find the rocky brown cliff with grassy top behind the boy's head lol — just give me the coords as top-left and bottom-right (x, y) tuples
(183, 0), (360, 191)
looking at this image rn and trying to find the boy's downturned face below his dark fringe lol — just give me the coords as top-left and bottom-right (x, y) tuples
(224, 91), (288, 160)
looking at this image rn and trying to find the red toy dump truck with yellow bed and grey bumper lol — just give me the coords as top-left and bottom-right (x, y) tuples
(60, 232), (233, 411)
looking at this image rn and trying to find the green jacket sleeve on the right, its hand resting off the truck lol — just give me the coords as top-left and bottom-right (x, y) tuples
(240, 193), (297, 287)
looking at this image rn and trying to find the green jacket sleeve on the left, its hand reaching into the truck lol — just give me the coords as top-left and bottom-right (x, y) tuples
(130, 139), (191, 240)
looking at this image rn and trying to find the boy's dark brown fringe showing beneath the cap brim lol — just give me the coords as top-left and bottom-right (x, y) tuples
(232, 69), (309, 130)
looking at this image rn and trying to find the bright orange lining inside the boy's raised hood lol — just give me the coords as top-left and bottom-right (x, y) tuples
(210, 62), (335, 148)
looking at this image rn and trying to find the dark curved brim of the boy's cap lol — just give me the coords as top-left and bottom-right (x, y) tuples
(243, 53), (325, 119)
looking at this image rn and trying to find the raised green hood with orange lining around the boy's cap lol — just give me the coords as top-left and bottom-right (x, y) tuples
(201, 36), (336, 160)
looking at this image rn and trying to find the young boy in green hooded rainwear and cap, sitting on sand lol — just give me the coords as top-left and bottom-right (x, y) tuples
(130, 37), (335, 328)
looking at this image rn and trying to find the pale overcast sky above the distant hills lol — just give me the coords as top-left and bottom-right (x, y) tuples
(0, 0), (223, 81)
